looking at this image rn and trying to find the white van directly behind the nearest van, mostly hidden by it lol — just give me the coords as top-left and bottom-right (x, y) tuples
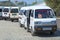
(19, 7), (28, 27)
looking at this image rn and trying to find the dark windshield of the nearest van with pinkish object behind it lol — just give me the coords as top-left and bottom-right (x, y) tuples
(35, 9), (55, 18)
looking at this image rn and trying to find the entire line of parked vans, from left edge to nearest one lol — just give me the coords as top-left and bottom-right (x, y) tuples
(0, 6), (57, 35)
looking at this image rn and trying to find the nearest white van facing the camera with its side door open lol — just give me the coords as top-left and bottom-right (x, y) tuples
(21, 6), (57, 35)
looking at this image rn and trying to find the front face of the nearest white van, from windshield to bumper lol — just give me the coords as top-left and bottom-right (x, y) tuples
(30, 9), (57, 32)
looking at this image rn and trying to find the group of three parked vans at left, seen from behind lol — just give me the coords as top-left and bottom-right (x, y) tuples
(0, 7), (19, 22)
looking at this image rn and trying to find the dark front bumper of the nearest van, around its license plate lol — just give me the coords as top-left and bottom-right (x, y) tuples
(34, 25), (57, 32)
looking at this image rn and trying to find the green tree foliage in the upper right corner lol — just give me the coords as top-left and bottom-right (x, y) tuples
(45, 0), (60, 16)
